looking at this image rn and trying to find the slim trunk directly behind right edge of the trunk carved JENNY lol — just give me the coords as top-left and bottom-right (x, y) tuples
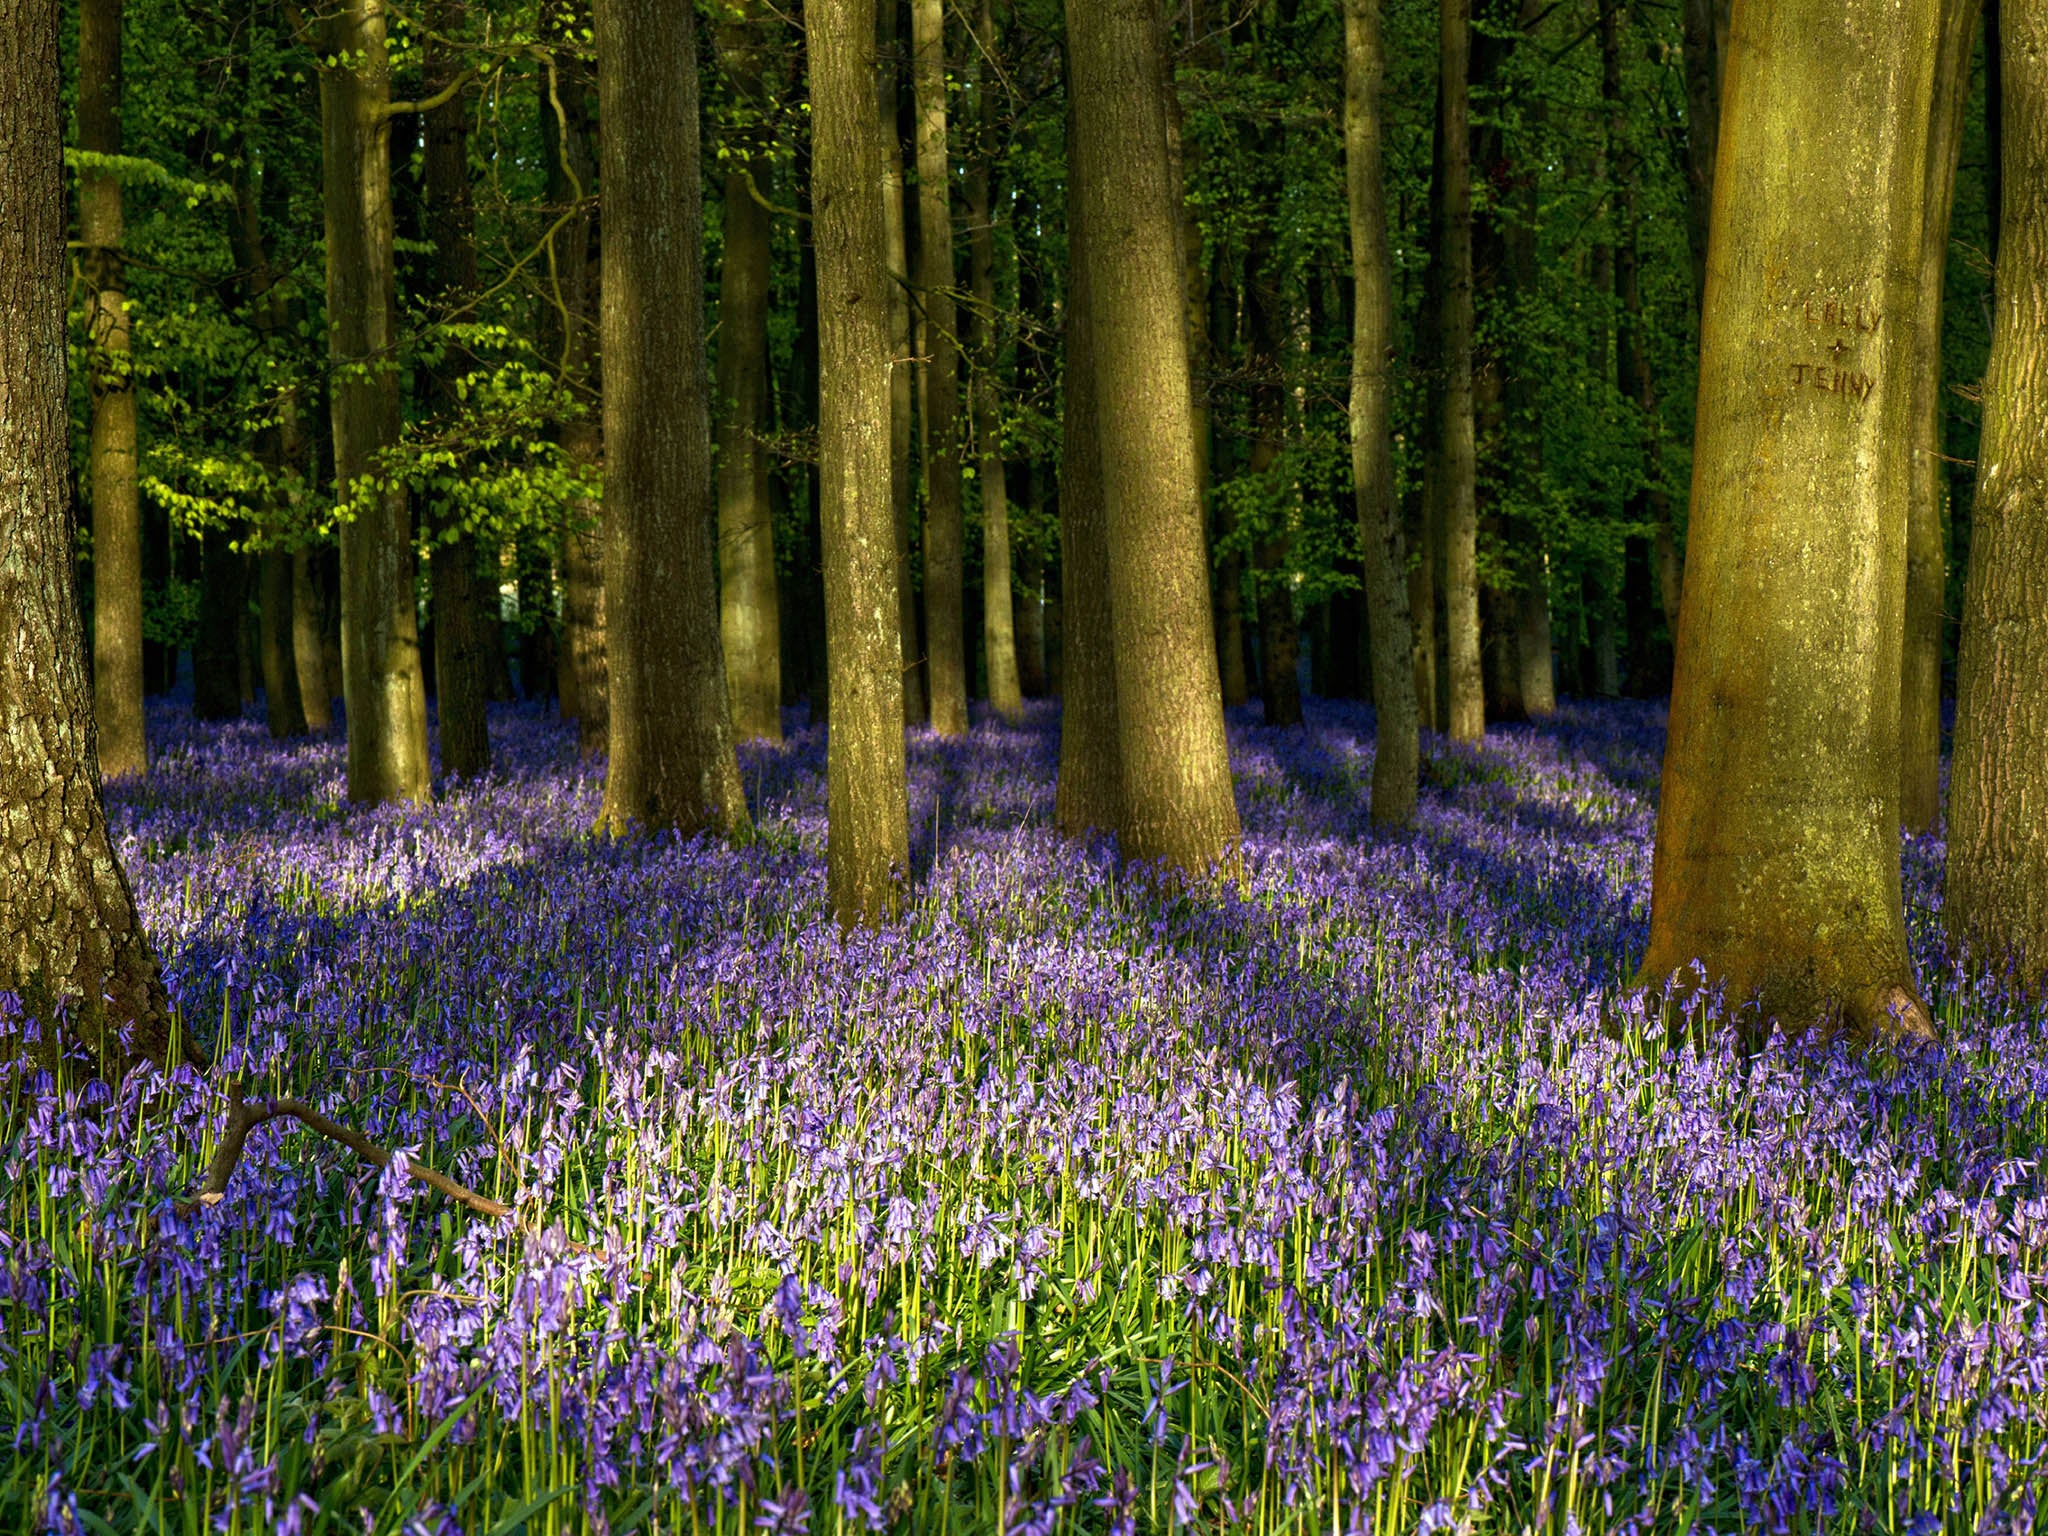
(1898, 0), (1978, 834)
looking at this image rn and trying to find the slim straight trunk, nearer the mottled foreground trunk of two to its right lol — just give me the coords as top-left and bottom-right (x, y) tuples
(909, 0), (967, 735)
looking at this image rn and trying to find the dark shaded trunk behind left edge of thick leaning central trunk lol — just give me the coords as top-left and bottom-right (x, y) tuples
(1053, 93), (1124, 838)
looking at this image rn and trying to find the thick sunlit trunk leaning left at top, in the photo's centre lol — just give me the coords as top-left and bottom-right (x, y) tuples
(1067, 0), (1239, 870)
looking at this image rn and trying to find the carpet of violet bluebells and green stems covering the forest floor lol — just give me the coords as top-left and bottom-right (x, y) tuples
(0, 705), (2048, 1536)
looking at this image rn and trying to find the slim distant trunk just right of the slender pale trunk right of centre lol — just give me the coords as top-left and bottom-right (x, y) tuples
(1436, 0), (1487, 741)
